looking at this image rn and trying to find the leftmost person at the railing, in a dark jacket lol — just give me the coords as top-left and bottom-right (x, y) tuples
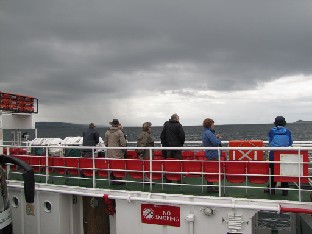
(82, 123), (99, 157)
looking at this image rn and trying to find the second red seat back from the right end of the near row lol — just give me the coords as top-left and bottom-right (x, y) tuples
(225, 161), (246, 184)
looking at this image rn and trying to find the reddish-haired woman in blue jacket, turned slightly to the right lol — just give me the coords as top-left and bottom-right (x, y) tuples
(202, 118), (222, 192)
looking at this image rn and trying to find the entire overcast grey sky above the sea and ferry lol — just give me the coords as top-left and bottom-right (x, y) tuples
(0, 0), (312, 126)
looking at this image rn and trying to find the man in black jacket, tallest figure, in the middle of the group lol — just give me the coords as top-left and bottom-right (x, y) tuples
(160, 114), (185, 159)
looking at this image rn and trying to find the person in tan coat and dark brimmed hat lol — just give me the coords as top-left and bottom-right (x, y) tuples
(104, 119), (127, 184)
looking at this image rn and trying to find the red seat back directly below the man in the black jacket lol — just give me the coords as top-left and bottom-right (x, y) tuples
(163, 158), (182, 181)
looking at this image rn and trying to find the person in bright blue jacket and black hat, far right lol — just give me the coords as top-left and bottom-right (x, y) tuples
(264, 116), (293, 196)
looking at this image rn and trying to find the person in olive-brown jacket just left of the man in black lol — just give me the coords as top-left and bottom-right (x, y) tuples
(136, 122), (154, 159)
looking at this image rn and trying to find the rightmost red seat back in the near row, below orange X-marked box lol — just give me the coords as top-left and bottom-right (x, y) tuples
(247, 161), (270, 184)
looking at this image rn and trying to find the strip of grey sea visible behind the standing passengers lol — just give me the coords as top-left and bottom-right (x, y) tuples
(31, 122), (312, 141)
